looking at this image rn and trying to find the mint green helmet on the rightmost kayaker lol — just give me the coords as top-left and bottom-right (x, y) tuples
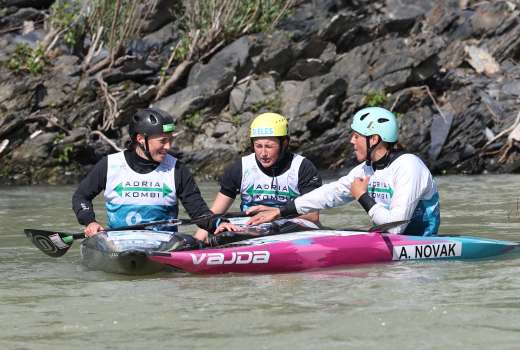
(350, 107), (399, 143)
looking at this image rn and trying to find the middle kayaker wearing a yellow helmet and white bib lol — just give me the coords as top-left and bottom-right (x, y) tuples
(195, 112), (322, 240)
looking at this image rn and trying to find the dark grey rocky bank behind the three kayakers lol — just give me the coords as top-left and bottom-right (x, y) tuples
(0, 0), (520, 184)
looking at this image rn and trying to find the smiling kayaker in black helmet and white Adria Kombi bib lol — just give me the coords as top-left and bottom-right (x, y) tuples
(72, 108), (214, 236)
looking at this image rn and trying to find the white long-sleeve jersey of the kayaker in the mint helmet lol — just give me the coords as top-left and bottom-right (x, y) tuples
(294, 153), (440, 236)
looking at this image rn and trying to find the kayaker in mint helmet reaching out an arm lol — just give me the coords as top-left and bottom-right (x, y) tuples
(249, 107), (440, 236)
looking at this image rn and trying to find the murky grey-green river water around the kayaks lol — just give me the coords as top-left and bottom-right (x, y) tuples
(0, 175), (520, 350)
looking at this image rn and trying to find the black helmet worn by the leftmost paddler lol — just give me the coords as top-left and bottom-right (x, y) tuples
(129, 108), (175, 140)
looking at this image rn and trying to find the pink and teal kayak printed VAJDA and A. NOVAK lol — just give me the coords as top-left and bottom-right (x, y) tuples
(148, 230), (520, 274)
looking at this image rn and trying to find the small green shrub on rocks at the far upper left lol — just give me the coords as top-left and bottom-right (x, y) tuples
(7, 43), (49, 75)
